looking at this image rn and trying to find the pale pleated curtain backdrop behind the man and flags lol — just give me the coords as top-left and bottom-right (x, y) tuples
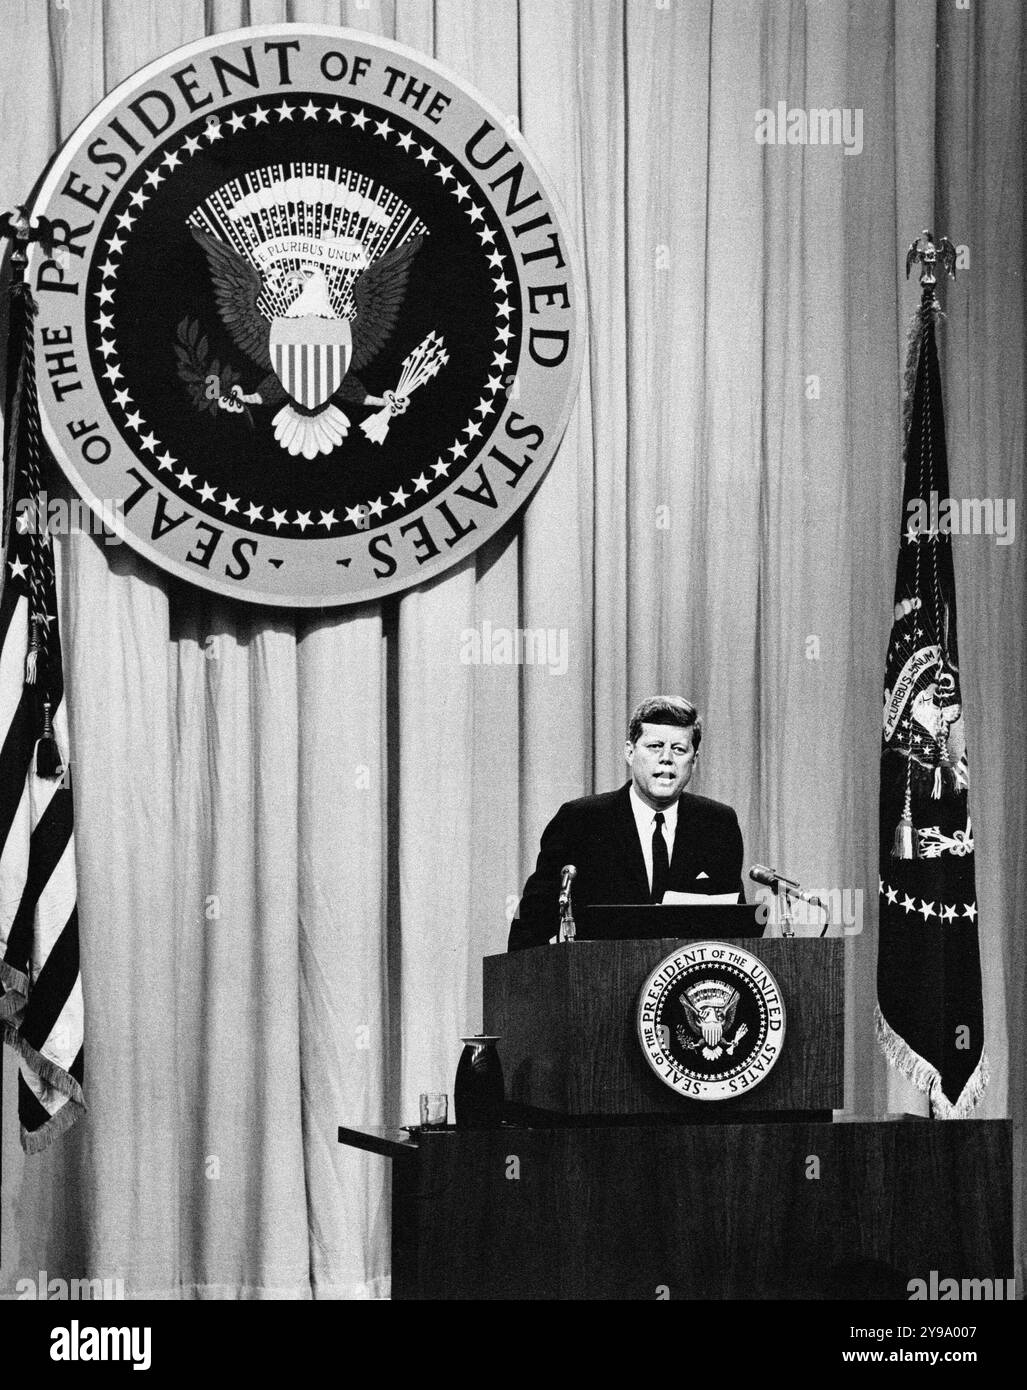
(0, 0), (1027, 1298)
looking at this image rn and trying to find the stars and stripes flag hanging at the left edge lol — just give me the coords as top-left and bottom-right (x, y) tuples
(0, 273), (85, 1154)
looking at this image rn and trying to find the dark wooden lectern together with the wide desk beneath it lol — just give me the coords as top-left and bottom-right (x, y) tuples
(339, 938), (1013, 1300)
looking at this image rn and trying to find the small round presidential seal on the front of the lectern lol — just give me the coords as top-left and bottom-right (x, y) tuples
(638, 941), (785, 1101)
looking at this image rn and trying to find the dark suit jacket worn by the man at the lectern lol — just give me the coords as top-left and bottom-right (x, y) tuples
(509, 783), (745, 951)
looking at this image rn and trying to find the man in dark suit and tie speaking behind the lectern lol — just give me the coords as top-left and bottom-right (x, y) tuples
(509, 695), (745, 951)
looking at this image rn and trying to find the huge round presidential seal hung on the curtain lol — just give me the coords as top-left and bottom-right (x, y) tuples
(31, 25), (585, 606)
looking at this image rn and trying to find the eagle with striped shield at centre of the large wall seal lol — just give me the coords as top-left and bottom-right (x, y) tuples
(178, 168), (449, 459)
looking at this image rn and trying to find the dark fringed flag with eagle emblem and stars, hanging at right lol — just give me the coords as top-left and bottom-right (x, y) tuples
(877, 279), (988, 1119)
